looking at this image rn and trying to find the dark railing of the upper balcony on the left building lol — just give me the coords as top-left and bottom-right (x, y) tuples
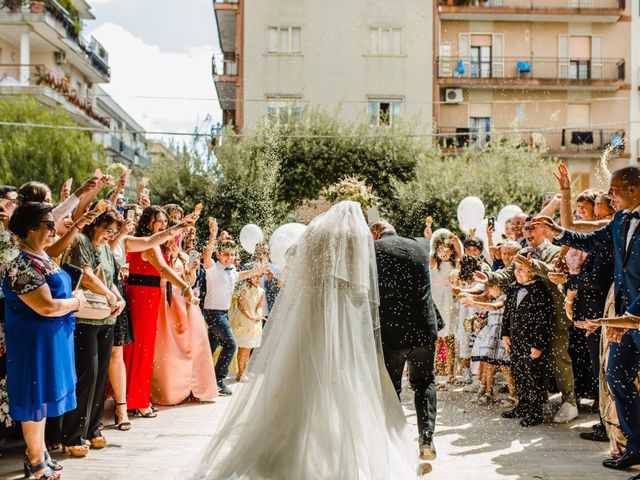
(0, 0), (111, 79)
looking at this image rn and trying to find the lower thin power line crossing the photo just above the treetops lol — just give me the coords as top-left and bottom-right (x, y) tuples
(0, 120), (640, 139)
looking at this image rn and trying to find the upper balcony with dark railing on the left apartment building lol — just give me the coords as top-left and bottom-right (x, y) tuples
(0, 0), (111, 83)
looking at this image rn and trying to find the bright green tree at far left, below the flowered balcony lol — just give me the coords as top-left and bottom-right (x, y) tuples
(0, 95), (104, 196)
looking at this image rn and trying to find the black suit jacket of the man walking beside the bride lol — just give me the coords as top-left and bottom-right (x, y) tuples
(374, 233), (438, 350)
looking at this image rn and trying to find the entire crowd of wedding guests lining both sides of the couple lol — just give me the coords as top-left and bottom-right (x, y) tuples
(0, 165), (640, 480)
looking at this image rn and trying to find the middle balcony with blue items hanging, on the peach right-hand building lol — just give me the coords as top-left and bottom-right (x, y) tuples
(438, 57), (625, 91)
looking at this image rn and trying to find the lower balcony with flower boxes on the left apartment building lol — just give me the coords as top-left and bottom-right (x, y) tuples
(0, 64), (111, 127)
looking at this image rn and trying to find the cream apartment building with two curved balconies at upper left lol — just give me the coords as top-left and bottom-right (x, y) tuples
(0, 0), (111, 128)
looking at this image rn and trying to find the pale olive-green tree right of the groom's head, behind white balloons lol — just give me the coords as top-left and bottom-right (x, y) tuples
(386, 139), (557, 235)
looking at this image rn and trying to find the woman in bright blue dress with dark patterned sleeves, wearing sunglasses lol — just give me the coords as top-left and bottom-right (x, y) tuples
(2, 202), (85, 480)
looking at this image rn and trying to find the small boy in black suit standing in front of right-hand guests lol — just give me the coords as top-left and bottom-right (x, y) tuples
(502, 266), (553, 427)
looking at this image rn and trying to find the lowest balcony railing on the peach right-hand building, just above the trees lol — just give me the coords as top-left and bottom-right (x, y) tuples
(437, 127), (625, 155)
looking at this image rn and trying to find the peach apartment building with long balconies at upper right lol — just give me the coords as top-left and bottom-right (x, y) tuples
(434, 0), (638, 187)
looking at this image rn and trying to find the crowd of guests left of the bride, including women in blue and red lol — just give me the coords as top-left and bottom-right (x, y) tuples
(0, 171), (272, 480)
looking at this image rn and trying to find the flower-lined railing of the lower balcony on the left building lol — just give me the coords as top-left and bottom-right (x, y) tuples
(0, 64), (111, 127)
